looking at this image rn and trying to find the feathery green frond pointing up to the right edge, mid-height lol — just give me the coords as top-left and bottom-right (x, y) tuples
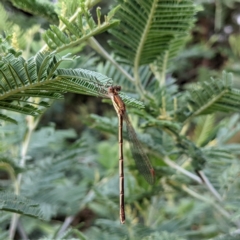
(179, 72), (240, 121)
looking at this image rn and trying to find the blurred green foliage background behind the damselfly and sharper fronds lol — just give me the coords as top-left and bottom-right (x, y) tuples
(0, 0), (240, 240)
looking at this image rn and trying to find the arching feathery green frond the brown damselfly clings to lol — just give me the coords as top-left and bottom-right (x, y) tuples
(0, 52), (143, 122)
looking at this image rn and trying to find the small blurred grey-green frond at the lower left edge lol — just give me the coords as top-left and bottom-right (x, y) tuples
(0, 192), (42, 219)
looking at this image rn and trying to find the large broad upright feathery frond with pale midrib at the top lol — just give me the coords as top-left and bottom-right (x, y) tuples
(111, 0), (196, 67)
